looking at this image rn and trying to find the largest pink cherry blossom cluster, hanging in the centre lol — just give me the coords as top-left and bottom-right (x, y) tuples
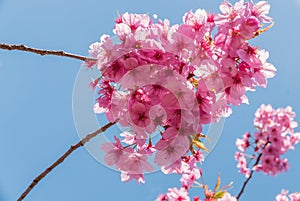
(85, 0), (276, 185)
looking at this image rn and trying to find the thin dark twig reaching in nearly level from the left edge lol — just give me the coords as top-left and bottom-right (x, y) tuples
(0, 43), (95, 61)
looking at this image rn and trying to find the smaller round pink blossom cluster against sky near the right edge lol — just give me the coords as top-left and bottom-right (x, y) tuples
(235, 105), (300, 177)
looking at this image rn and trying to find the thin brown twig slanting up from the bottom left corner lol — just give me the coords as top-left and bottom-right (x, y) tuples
(18, 122), (116, 201)
